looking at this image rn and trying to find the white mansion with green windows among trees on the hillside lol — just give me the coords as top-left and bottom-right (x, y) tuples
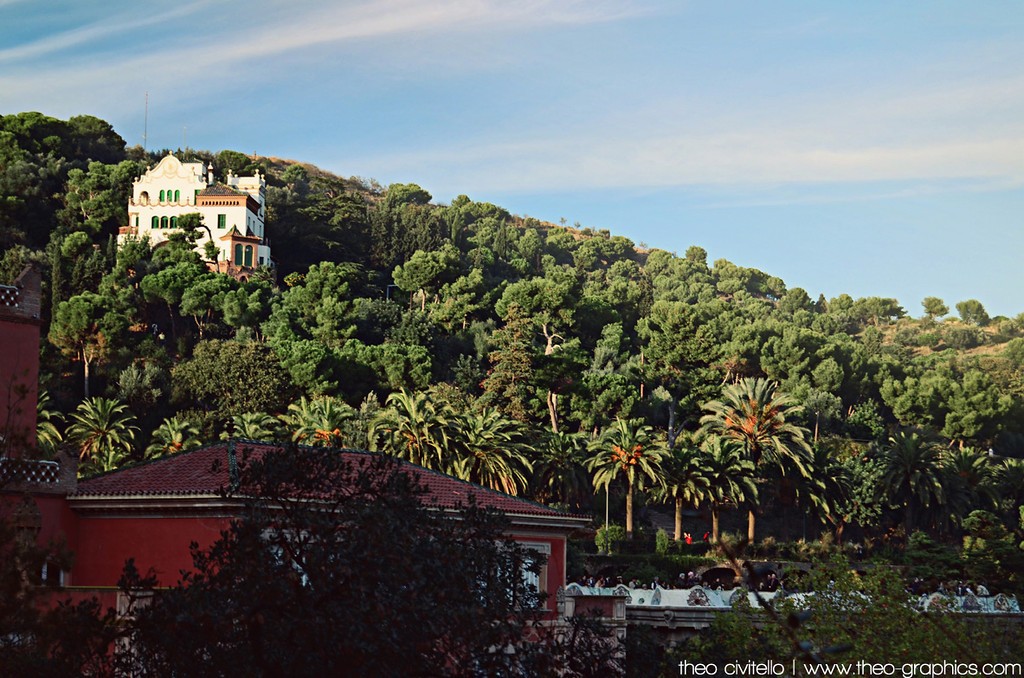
(118, 155), (273, 274)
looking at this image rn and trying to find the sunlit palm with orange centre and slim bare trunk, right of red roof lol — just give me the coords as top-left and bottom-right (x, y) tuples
(587, 418), (668, 539)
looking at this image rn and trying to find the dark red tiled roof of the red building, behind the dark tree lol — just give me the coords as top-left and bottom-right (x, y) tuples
(72, 441), (581, 520)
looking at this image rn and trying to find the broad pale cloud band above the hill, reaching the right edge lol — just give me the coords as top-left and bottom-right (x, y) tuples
(346, 67), (1024, 196)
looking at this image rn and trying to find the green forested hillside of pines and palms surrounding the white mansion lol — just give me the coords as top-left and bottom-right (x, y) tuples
(6, 114), (1024, 548)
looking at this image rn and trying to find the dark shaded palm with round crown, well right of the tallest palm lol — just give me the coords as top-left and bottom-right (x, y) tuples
(879, 431), (945, 537)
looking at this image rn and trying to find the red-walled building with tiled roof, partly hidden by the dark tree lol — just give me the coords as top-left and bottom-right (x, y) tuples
(60, 442), (590, 612)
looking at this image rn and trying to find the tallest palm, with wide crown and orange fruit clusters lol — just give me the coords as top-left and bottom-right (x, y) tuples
(699, 378), (811, 542)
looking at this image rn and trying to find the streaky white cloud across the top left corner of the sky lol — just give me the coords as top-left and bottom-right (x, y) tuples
(0, 0), (652, 115)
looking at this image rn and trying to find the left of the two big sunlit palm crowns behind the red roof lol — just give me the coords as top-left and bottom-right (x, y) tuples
(369, 389), (455, 471)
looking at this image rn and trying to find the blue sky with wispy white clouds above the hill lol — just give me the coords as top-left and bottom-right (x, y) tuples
(6, 0), (1024, 316)
